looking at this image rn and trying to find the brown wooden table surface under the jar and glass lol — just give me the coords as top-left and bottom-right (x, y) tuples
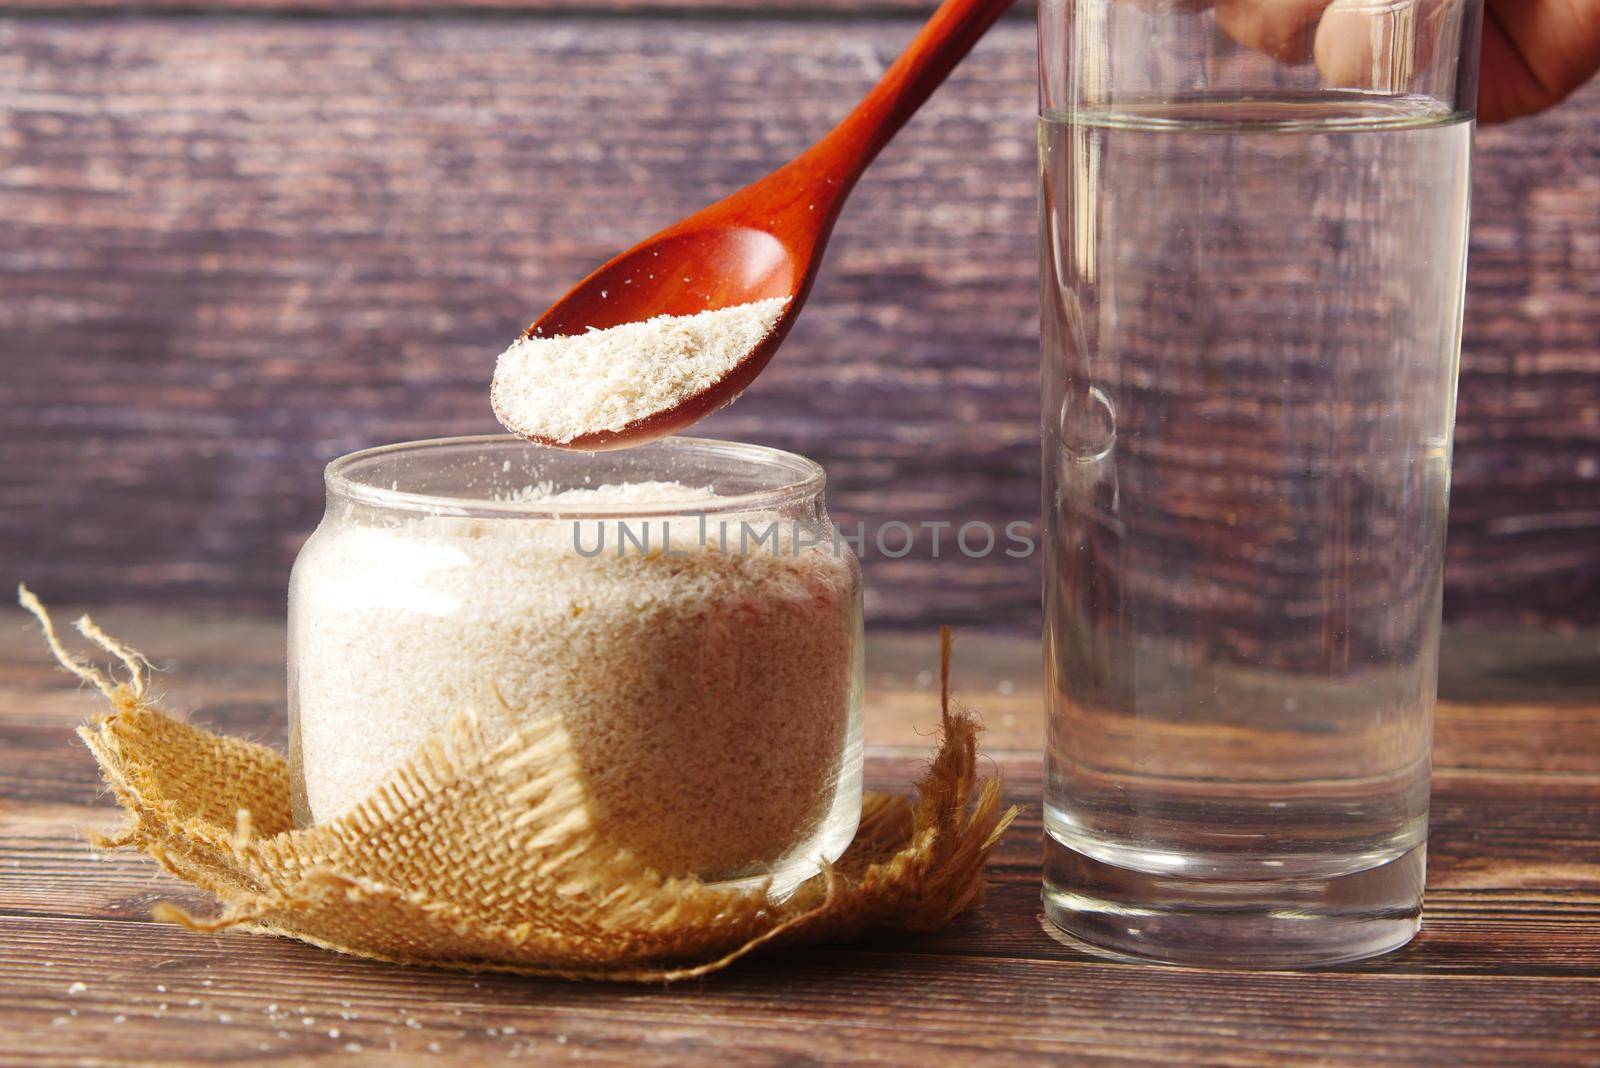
(0, 612), (1600, 1065)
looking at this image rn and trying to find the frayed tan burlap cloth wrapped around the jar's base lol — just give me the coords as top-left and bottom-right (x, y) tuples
(19, 588), (1016, 982)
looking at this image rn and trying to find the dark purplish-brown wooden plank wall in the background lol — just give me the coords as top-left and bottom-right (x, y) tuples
(0, 0), (1600, 628)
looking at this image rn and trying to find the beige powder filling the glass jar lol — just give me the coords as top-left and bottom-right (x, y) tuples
(291, 483), (859, 878)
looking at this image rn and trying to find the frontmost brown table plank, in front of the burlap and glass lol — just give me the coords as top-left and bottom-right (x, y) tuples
(12, 918), (1597, 1066)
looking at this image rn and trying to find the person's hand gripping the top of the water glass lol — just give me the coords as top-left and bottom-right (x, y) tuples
(1202, 0), (1600, 123)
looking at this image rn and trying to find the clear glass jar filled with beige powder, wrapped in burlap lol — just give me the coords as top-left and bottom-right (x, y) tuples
(288, 436), (862, 892)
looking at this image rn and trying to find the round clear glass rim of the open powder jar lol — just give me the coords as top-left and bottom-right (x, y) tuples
(323, 433), (827, 520)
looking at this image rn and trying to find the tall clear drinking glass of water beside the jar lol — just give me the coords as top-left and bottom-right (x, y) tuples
(1038, 0), (1482, 966)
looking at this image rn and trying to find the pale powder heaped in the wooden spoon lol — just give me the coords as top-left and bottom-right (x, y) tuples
(490, 297), (789, 441)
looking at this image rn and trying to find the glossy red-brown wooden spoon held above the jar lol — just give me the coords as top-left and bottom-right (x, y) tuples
(502, 0), (1013, 449)
